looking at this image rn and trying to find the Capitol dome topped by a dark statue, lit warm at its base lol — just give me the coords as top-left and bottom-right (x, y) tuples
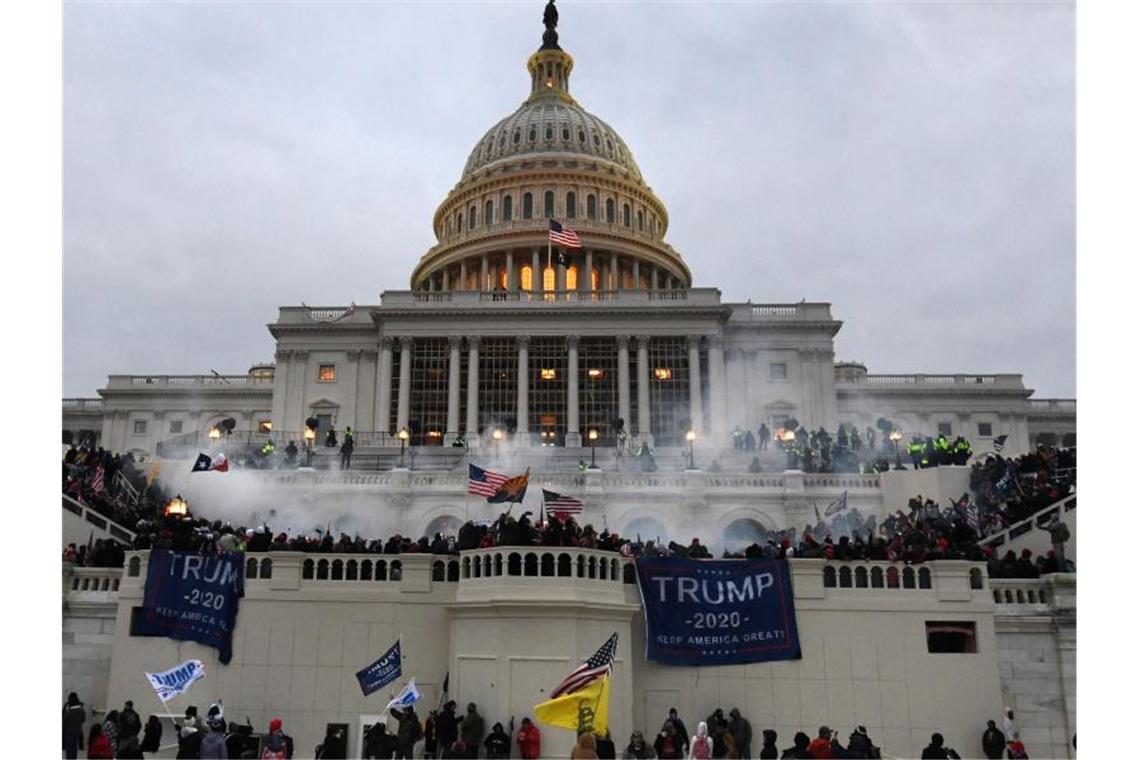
(412, 2), (692, 301)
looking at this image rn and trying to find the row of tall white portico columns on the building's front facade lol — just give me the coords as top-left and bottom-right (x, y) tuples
(375, 335), (726, 447)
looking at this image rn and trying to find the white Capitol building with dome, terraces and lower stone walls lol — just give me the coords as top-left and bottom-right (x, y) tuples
(63, 5), (1076, 757)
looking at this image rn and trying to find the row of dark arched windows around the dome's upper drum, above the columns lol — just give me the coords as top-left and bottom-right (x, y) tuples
(443, 190), (658, 239)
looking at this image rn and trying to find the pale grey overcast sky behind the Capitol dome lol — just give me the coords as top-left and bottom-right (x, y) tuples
(63, 0), (1076, 398)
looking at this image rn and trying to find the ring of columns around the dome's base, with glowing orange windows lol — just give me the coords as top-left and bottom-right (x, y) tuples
(426, 248), (682, 293)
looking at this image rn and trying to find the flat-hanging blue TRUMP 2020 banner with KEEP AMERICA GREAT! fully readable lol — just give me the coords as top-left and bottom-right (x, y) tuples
(637, 557), (800, 665)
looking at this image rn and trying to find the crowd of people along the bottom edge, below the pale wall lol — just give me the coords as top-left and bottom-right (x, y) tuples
(63, 692), (1039, 760)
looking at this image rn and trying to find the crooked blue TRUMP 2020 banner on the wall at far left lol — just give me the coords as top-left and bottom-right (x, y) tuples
(132, 550), (245, 664)
